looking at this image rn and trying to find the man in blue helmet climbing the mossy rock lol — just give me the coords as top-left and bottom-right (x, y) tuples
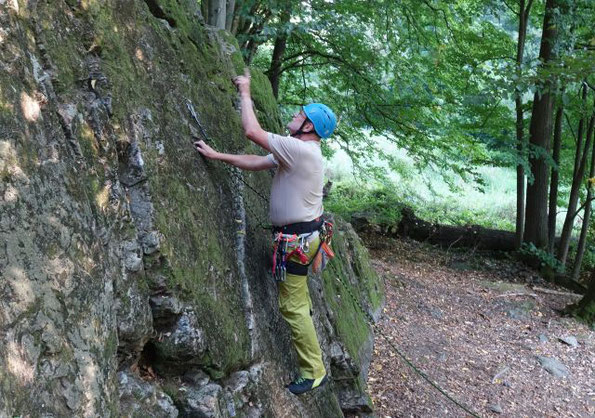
(195, 69), (337, 395)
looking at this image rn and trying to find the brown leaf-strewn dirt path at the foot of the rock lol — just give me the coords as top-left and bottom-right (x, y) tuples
(368, 237), (595, 418)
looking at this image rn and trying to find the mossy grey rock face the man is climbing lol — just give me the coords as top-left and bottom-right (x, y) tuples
(0, 0), (383, 417)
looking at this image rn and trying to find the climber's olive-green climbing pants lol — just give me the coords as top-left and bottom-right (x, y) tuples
(279, 237), (326, 379)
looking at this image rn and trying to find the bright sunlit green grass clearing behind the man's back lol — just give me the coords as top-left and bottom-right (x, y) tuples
(325, 143), (516, 231)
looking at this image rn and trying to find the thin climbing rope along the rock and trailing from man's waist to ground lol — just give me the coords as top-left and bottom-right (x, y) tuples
(186, 100), (480, 418)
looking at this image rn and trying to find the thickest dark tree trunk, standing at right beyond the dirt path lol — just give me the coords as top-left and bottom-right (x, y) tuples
(524, 0), (558, 249)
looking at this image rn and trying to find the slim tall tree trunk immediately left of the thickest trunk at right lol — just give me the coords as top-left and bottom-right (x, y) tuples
(514, 0), (533, 248)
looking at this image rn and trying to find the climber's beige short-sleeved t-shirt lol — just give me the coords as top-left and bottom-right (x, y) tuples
(268, 133), (324, 226)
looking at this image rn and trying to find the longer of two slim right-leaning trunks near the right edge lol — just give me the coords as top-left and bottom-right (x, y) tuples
(557, 90), (594, 264)
